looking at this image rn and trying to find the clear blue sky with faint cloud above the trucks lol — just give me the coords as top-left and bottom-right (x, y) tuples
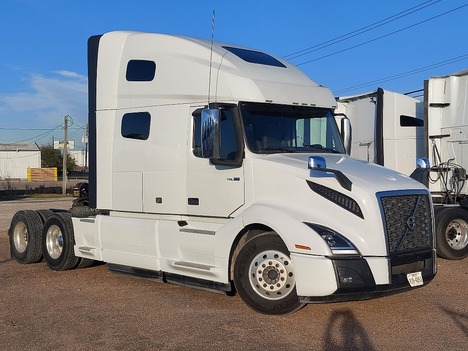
(0, 0), (468, 148)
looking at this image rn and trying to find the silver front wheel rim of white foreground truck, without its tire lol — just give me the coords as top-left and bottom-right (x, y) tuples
(249, 250), (295, 300)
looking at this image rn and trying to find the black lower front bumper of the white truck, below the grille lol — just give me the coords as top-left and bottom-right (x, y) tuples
(298, 250), (436, 303)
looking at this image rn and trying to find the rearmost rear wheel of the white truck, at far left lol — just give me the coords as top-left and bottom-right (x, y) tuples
(8, 210), (42, 264)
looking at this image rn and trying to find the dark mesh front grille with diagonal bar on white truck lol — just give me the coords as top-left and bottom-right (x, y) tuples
(379, 194), (433, 255)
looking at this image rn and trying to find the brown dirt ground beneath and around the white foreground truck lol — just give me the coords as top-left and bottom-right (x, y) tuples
(0, 198), (468, 351)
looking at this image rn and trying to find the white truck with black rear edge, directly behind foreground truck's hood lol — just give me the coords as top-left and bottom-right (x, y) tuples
(335, 88), (425, 175)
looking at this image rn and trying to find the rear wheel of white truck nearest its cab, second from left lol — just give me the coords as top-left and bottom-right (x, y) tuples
(42, 212), (80, 271)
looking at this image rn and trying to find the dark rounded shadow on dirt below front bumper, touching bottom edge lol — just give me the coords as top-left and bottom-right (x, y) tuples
(323, 309), (375, 351)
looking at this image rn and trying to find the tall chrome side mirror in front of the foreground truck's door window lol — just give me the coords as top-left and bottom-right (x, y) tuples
(201, 109), (221, 158)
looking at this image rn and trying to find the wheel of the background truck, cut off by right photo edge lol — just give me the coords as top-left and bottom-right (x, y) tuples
(435, 207), (468, 260)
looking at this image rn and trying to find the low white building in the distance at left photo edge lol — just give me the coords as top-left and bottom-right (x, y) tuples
(0, 143), (41, 179)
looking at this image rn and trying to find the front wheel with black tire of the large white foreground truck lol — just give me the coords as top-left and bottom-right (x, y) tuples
(234, 232), (303, 314)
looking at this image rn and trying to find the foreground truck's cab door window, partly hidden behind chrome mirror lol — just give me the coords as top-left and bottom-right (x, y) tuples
(192, 109), (239, 161)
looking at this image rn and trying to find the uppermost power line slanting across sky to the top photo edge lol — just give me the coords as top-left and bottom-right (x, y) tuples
(283, 0), (442, 60)
